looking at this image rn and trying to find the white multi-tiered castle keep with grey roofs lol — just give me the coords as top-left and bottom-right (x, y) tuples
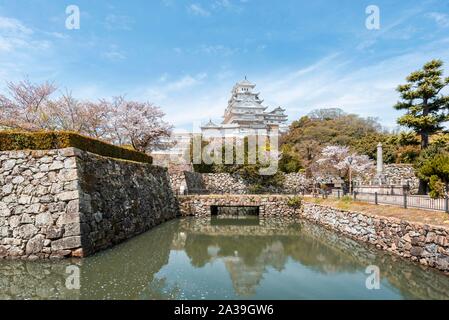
(201, 77), (287, 138)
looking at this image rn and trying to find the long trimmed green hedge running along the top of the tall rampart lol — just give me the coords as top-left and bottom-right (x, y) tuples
(0, 131), (153, 163)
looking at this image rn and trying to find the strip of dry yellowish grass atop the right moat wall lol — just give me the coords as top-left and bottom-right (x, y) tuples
(303, 197), (449, 228)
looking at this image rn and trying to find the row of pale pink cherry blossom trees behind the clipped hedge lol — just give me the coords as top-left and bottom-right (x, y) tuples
(0, 80), (172, 152)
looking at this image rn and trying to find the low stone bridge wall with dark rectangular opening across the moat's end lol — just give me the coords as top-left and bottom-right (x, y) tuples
(179, 194), (300, 217)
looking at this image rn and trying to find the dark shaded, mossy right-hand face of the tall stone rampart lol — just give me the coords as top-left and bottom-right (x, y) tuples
(77, 152), (179, 254)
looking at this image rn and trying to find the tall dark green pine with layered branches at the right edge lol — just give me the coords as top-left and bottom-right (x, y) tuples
(394, 60), (449, 149)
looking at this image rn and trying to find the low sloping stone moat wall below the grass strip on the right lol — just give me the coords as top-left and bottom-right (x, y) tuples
(301, 202), (449, 272)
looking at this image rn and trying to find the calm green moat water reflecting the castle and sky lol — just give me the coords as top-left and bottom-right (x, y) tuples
(0, 217), (449, 299)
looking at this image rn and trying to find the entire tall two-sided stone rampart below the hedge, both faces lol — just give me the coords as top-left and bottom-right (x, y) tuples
(0, 148), (179, 259)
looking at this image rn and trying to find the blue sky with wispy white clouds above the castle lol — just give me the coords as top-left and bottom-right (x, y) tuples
(0, 0), (449, 129)
